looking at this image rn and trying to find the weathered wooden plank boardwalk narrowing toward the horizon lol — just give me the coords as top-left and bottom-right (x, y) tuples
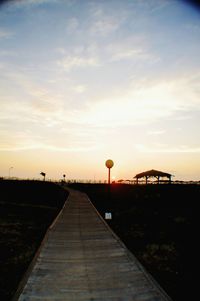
(15, 190), (171, 301)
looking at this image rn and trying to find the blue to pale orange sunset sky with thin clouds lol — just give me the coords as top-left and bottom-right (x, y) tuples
(0, 0), (200, 181)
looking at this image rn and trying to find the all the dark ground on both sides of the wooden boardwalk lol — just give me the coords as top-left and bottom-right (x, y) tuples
(0, 180), (197, 301)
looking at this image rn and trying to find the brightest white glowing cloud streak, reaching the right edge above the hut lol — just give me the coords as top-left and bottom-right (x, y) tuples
(65, 71), (200, 127)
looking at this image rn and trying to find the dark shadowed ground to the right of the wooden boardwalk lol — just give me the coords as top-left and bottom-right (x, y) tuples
(69, 184), (197, 301)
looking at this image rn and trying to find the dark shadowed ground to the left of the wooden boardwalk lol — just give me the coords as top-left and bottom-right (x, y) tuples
(0, 180), (68, 301)
